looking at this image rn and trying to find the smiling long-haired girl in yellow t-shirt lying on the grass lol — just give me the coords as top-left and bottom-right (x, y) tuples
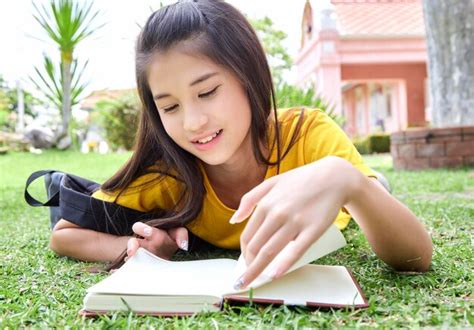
(51, 0), (432, 287)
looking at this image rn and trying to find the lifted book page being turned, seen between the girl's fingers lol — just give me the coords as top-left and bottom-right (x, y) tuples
(226, 224), (346, 293)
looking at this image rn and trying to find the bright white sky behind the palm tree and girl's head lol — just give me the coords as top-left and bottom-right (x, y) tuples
(0, 0), (325, 92)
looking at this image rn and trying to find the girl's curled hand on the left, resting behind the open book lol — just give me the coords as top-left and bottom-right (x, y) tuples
(127, 222), (188, 259)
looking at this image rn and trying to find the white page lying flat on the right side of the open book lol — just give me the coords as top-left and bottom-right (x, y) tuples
(228, 265), (364, 306)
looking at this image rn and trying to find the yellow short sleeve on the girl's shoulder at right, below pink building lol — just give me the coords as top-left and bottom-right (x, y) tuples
(304, 109), (376, 177)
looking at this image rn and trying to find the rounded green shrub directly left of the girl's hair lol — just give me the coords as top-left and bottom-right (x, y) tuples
(95, 92), (140, 150)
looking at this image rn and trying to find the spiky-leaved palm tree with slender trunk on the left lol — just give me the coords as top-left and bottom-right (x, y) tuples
(33, 0), (99, 140)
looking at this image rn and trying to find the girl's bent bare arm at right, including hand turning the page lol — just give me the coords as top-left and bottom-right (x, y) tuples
(230, 156), (432, 287)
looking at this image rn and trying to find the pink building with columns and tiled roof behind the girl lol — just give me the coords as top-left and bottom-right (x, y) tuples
(295, 0), (430, 136)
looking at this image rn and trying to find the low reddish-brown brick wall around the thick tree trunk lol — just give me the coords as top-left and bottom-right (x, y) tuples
(390, 126), (474, 170)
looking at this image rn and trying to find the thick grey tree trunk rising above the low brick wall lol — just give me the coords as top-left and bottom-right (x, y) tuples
(423, 0), (474, 127)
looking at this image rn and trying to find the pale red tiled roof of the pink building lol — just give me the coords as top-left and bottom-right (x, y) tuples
(331, 0), (425, 37)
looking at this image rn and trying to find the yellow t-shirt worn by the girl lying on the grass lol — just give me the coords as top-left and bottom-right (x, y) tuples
(93, 108), (375, 249)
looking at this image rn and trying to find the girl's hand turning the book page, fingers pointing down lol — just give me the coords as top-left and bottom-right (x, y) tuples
(230, 156), (362, 289)
